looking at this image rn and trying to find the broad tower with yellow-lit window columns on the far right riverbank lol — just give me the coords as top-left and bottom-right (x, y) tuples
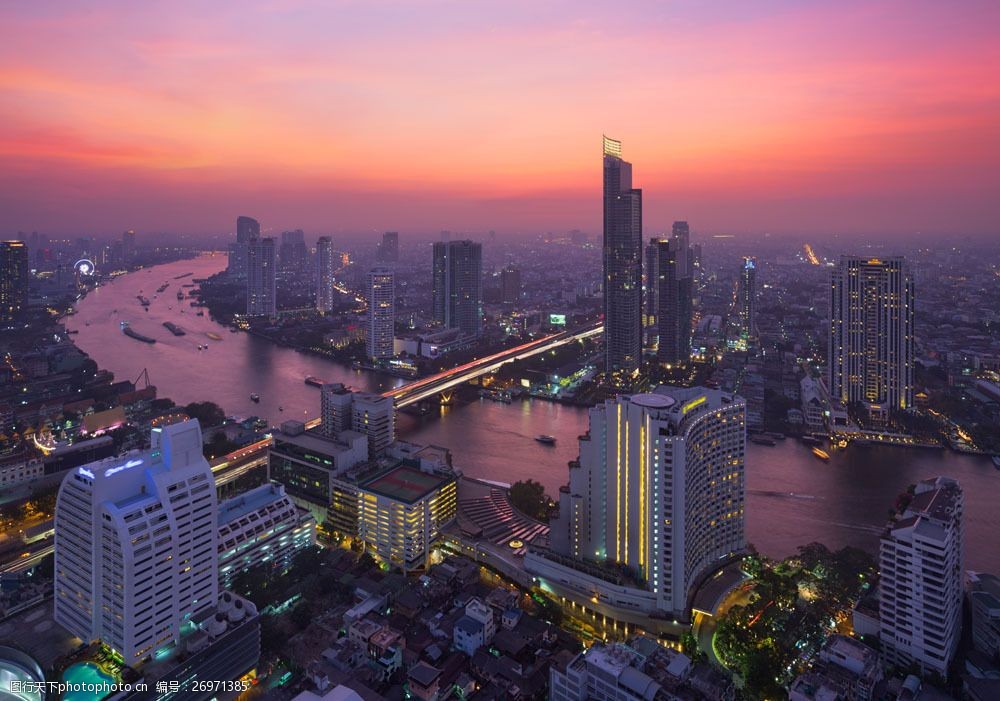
(828, 256), (913, 419)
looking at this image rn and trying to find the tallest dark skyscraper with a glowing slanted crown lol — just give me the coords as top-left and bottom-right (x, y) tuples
(604, 137), (642, 372)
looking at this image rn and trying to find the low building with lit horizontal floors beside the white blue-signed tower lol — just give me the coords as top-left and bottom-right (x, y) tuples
(219, 483), (316, 589)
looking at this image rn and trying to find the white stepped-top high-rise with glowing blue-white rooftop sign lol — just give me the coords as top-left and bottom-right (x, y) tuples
(55, 420), (219, 665)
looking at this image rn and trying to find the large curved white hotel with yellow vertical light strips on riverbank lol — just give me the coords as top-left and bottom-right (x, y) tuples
(525, 386), (746, 616)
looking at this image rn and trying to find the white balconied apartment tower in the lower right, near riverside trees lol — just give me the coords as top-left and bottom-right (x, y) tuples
(879, 477), (963, 676)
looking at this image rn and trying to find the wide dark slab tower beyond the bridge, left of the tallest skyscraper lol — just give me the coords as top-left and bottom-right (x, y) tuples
(433, 241), (483, 336)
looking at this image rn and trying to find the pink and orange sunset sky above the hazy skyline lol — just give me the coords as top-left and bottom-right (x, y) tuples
(0, 0), (1000, 236)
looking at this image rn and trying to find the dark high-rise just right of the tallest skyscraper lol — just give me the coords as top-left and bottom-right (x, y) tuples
(651, 235), (692, 365)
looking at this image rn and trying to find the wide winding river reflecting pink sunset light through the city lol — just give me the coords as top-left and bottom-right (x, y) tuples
(66, 254), (1000, 573)
